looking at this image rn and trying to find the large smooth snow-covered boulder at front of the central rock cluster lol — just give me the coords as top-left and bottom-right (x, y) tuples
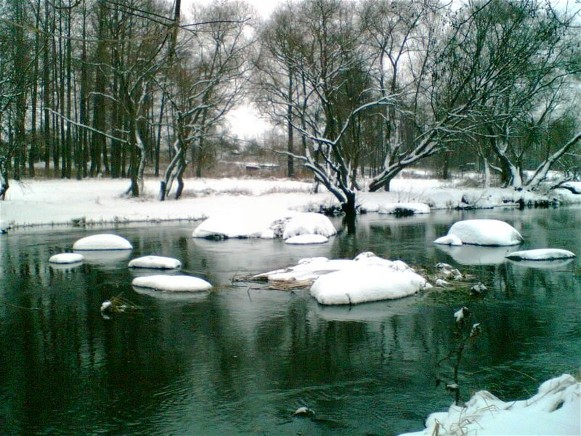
(311, 263), (429, 305)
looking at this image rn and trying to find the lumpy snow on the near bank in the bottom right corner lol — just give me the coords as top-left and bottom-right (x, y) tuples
(402, 374), (581, 436)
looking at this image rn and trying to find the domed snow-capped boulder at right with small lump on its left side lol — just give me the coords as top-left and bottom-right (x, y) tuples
(434, 219), (523, 246)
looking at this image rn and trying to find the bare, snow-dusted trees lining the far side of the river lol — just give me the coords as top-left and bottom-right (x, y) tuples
(0, 0), (581, 213)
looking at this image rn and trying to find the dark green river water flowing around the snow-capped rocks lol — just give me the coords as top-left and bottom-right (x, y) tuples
(0, 208), (581, 435)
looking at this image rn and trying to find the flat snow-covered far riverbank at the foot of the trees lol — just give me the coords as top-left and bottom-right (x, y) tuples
(0, 177), (581, 228)
